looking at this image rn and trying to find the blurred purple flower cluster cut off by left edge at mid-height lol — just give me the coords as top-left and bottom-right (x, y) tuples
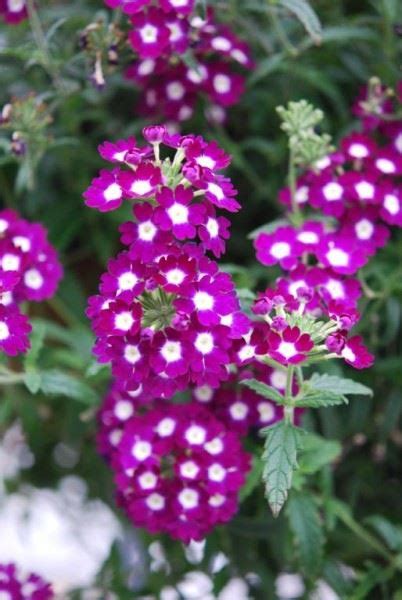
(0, 209), (62, 355)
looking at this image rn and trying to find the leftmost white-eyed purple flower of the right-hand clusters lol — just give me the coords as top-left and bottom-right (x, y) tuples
(254, 227), (303, 269)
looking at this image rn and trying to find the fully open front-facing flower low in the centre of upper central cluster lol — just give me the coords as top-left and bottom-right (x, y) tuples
(155, 185), (205, 240)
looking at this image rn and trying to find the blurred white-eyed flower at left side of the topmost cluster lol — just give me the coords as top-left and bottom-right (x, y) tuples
(128, 8), (170, 58)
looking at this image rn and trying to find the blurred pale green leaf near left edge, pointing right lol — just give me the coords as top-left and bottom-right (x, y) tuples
(41, 369), (99, 405)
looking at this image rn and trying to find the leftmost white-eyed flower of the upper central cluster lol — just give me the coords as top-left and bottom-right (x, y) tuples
(83, 169), (124, 212)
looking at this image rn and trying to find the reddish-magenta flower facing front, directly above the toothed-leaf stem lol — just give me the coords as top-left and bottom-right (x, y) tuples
(268, 327), (314, 365)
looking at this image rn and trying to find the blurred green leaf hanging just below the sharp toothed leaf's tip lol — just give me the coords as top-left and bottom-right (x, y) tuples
(286, 492), (324, 577)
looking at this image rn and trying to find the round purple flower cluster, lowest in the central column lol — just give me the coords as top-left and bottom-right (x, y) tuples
(105, 399), (249, 542)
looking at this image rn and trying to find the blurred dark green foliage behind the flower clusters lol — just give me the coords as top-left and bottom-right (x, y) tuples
(0, 0), (402, 600)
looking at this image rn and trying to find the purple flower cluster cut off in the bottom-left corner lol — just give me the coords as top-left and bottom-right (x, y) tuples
(0, 564), (54, 600)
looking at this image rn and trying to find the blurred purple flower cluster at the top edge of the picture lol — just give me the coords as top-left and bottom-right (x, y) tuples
(105, 0), (253, 122)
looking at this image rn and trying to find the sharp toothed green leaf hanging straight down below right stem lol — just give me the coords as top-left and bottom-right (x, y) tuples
(262, 421), (302, 517)
